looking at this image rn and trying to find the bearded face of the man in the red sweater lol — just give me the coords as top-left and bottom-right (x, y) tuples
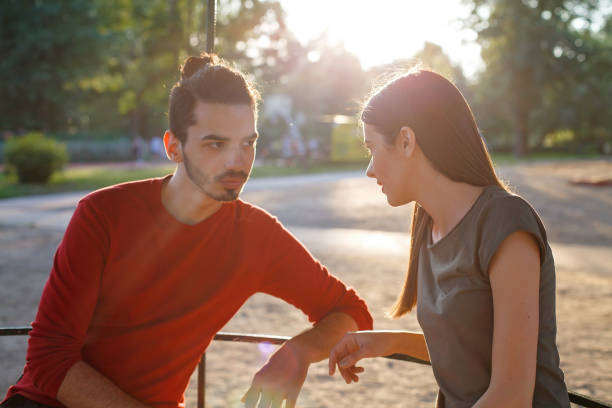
(181, 102), (257, 201)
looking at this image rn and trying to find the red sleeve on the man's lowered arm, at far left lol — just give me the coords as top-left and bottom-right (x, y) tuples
(25, 200), (108, 398)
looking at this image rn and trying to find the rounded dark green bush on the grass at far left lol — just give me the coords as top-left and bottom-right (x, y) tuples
(4, 132), (68, 183)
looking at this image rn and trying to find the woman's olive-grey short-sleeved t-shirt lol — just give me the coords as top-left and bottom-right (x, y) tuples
(417, 186), (570, 408)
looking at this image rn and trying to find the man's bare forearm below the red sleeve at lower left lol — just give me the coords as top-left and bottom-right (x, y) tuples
(57, 361), (146, 408)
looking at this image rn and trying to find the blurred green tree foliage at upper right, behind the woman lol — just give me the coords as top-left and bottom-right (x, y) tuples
(466, 0), (612, 156)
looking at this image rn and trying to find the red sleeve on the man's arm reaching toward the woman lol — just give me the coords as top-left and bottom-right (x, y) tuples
(255, 219), (372, 330)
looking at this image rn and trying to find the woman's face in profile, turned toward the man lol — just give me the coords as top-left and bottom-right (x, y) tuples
(363, 124), (413, 207)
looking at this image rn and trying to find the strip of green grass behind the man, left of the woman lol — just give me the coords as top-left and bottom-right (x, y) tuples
(0, 163), (366, 199)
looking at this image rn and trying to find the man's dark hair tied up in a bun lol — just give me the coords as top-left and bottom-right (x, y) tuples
(168, 53), (260, 143)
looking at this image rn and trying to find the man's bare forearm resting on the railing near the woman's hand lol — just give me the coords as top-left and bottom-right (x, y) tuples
(286, 312), (359, 363)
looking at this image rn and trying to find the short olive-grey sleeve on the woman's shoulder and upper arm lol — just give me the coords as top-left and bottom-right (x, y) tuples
(478, 196), (547, 281)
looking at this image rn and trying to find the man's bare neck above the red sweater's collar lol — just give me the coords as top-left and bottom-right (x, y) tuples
(161, 166), (223, 225)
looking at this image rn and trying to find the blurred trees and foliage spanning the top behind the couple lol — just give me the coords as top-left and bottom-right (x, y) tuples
(0, 0), (612, 158)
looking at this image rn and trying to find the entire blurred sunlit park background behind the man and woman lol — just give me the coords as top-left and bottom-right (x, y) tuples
(0, 0), (612, 407)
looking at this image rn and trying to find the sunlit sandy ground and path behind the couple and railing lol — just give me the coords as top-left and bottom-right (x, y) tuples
(0, 161), (612, 407)
